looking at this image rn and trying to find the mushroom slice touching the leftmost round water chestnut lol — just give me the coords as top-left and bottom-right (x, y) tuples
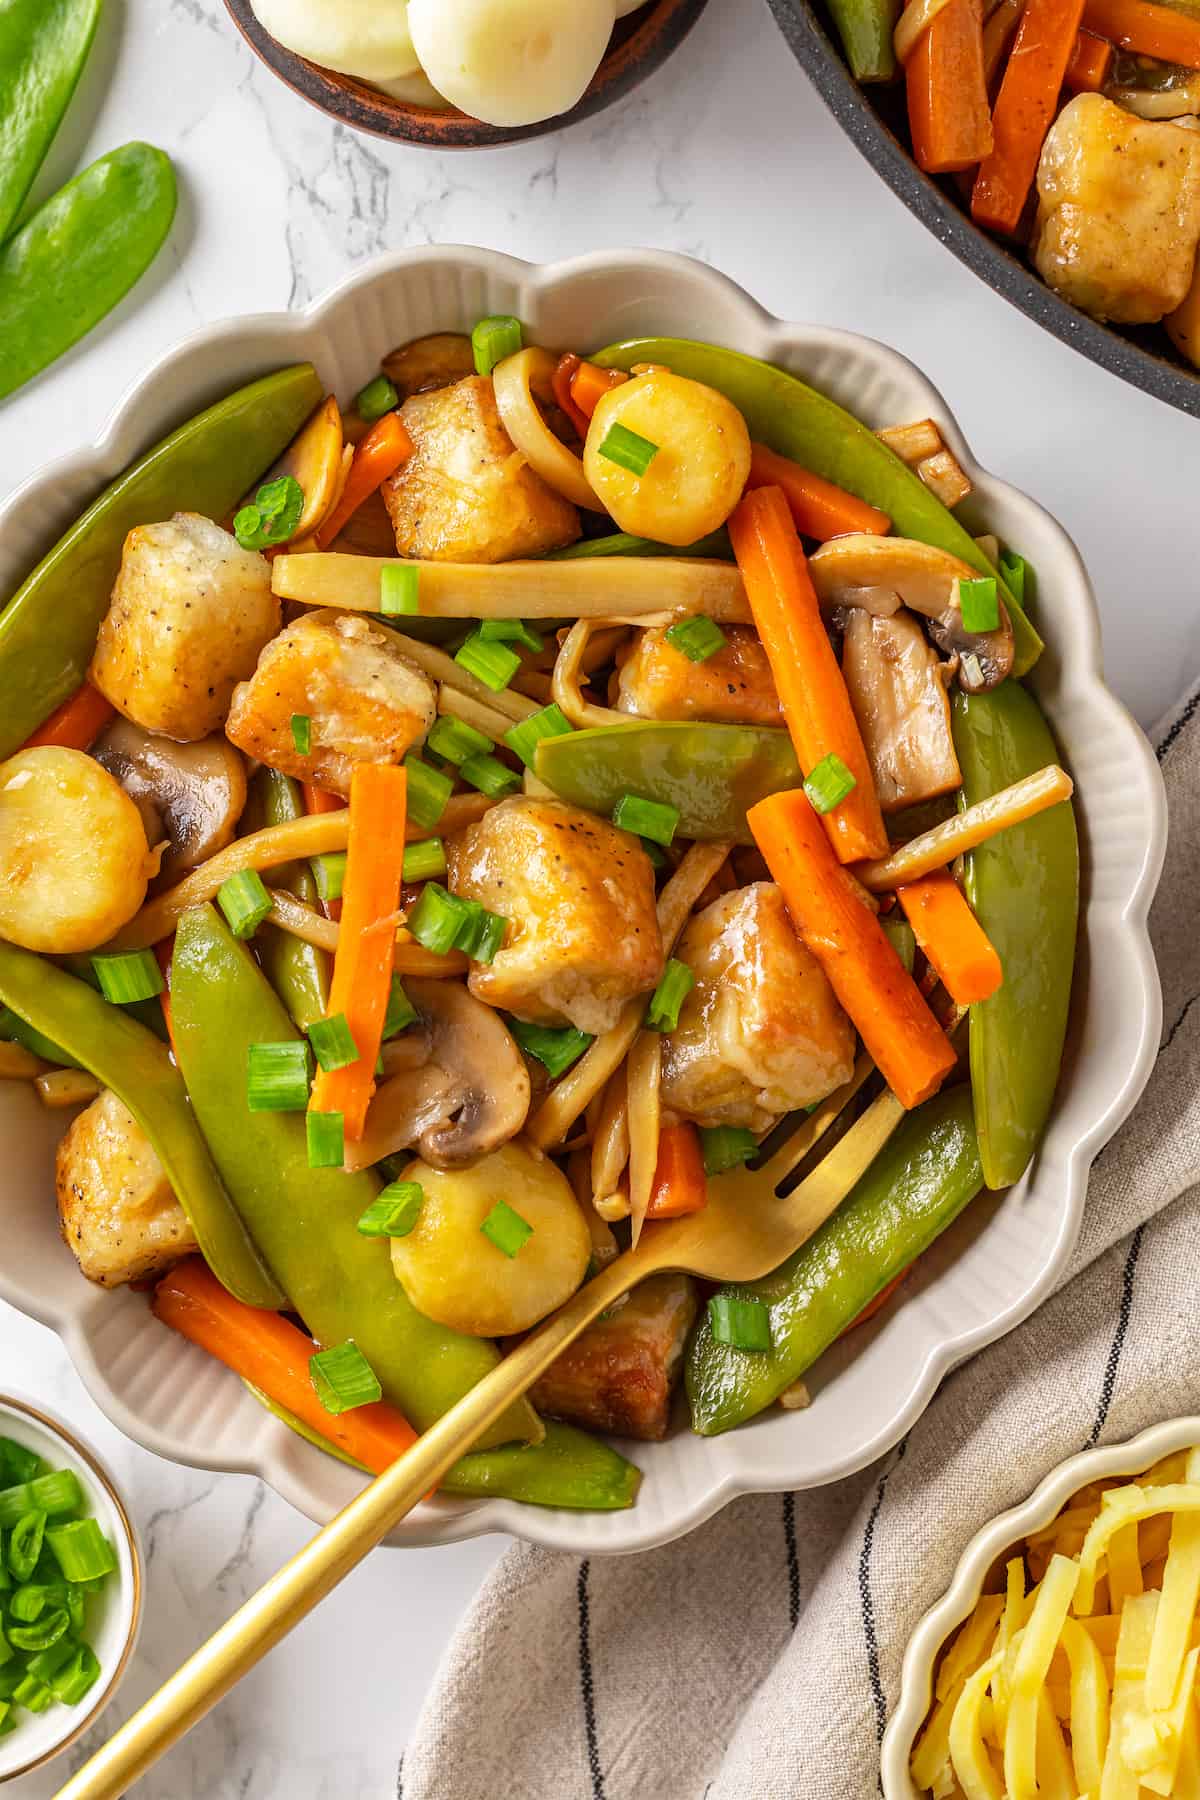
(92, 718), (246, 886)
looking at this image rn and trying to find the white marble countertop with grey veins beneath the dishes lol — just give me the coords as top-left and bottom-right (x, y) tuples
(0, 0), (1200, 1800)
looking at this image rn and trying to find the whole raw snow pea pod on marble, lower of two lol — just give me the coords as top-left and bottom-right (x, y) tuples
(0, 144), (176, 398)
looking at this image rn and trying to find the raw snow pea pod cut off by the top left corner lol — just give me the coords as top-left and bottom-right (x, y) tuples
(0, 0), (101, 243)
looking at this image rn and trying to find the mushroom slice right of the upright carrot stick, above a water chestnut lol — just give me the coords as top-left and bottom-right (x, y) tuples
(345, 977), (529, 1168)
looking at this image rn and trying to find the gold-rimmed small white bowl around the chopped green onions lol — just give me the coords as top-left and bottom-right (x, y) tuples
(0, 1393), (142, 1782)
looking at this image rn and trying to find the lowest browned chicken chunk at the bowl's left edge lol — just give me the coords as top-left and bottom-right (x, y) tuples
(54, 1089), (200, 1287)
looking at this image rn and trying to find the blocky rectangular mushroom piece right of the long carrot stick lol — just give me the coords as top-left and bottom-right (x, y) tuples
(842, 608), (963, 814)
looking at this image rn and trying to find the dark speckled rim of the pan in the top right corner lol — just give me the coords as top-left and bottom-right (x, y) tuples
(770, 0), (1200, 418)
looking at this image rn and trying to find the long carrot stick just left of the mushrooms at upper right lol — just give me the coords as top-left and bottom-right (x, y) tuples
(729, 488), (887, 862)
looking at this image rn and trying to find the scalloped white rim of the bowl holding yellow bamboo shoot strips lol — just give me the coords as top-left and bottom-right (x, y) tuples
(880, 1417), (1200, 1800)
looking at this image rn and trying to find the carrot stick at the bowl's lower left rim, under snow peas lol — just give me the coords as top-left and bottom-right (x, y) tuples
(153, 1256), (417, 1474)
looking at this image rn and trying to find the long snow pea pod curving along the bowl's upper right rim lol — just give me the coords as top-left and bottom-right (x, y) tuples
(590, 338), (1042, 675)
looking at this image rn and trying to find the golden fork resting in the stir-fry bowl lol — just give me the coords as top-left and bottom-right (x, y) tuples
(56, 1055), (903, 1800)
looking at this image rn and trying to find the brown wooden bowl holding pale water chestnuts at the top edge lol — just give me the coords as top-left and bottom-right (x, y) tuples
(225, 0), (707, 149)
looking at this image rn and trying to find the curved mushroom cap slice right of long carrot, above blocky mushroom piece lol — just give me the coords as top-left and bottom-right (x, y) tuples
(808, 531), (1013, 693)
